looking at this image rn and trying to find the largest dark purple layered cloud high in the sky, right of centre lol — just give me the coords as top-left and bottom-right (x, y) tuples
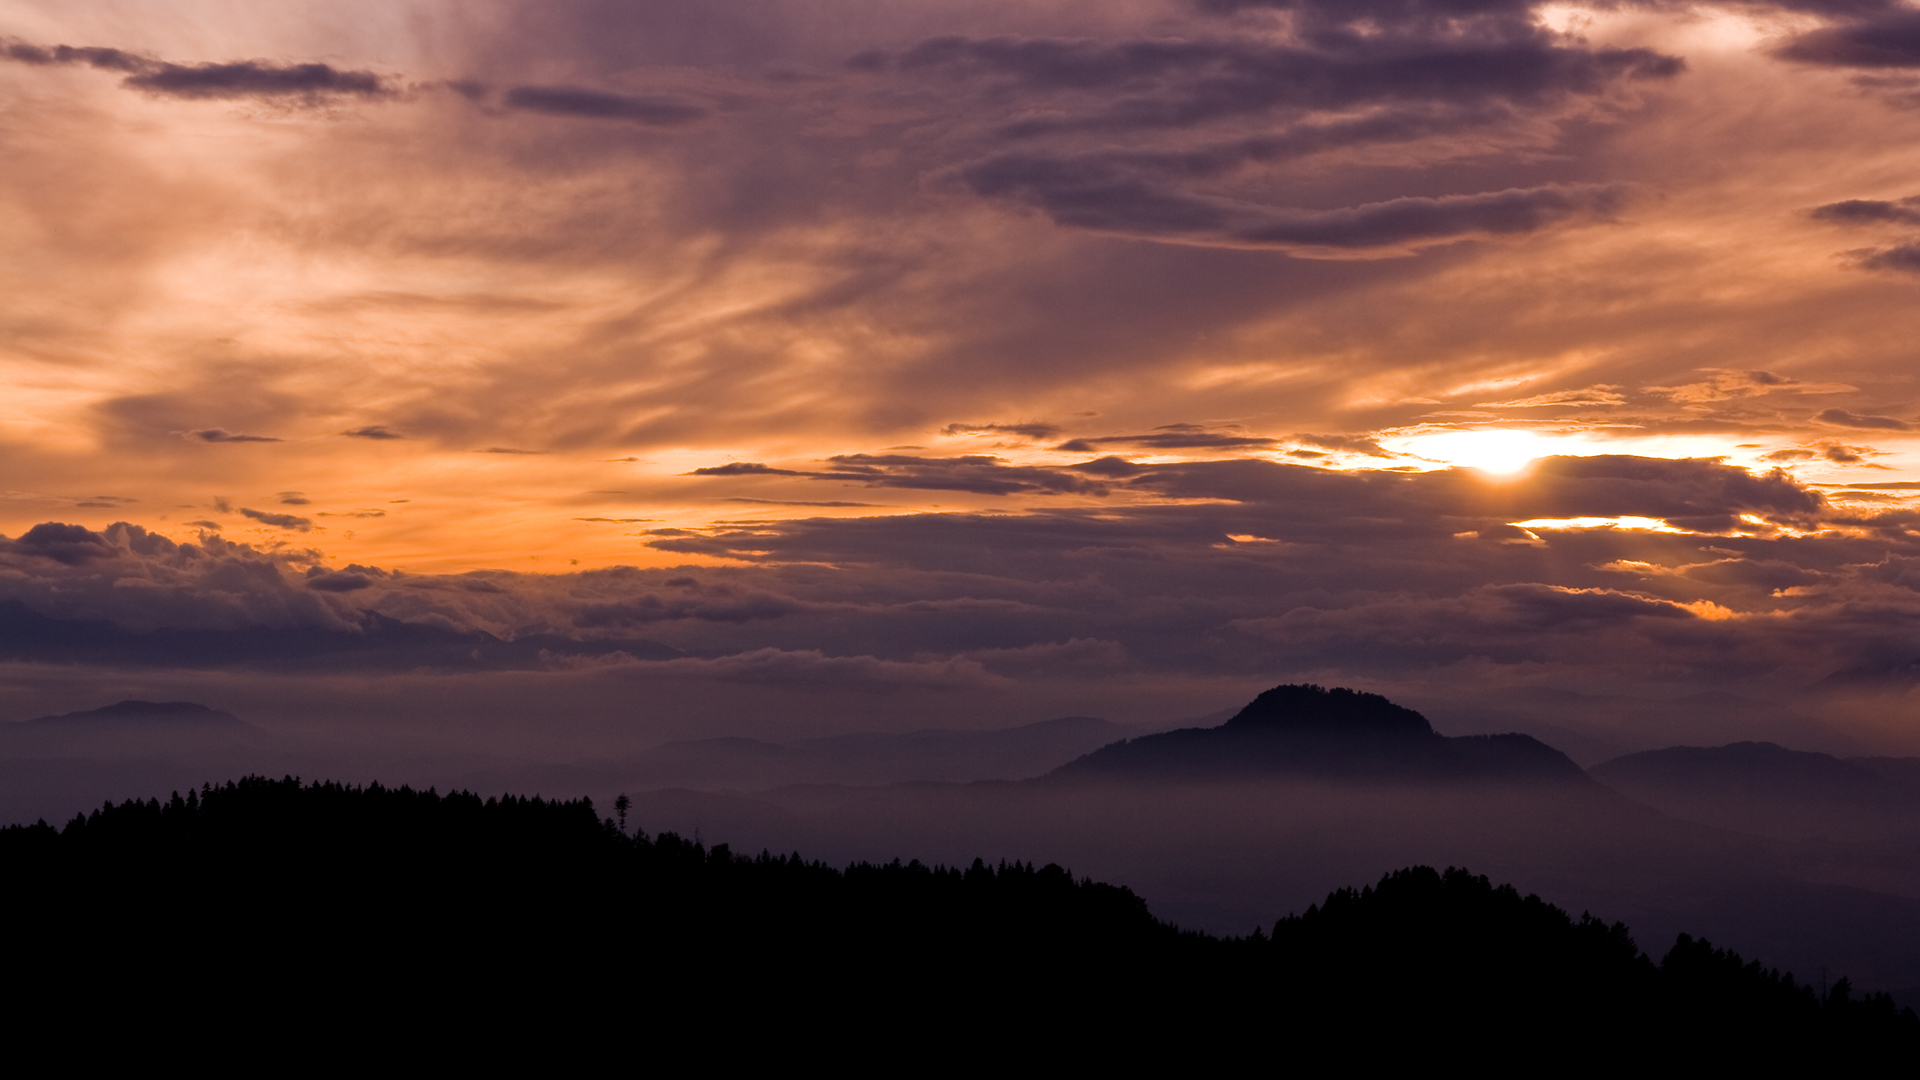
(856, 4), (1684, 252)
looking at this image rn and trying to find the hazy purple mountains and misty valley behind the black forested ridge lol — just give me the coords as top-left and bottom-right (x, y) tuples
(11, 686), (1920, 988)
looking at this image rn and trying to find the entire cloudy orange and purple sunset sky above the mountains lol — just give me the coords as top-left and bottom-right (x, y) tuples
(0, 0), (1920, 755)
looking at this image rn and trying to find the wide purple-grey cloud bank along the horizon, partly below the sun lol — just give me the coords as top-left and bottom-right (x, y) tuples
(0, 441), (1920, 692)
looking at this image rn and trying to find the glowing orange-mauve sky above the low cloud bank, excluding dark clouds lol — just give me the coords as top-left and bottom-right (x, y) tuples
(0, 4), (1920, 569)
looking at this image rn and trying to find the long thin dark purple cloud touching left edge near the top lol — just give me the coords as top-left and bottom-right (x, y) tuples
(0, 42), (397, 100)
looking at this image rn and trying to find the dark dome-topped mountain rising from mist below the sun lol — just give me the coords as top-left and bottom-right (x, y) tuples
(1052, 684), (1586, 782)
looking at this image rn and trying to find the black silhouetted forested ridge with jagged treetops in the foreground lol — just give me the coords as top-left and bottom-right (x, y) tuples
(0, 778), (1920, 1067)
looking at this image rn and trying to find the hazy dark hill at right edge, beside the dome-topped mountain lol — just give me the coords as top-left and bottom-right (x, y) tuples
(1592, 742), (1920, 840)
